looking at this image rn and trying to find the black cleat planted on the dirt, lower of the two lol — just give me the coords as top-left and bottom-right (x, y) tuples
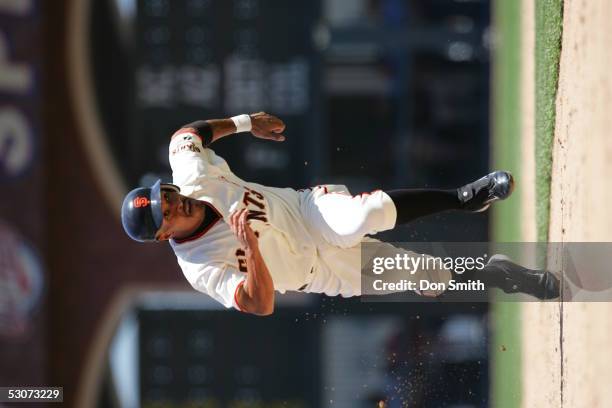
(482, 255), (561, 300)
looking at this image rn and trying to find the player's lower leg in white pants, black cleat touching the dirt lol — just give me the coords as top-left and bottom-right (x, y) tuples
(318, 238), (560, 300)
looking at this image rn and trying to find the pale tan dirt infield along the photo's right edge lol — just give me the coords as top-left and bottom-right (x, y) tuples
(522, 0), (612, 407)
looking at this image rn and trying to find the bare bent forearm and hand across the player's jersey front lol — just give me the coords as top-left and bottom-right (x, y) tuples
(230, 209), (274, 316)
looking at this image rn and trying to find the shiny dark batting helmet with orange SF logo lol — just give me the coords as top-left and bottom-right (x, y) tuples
(121, 180), (180, 242)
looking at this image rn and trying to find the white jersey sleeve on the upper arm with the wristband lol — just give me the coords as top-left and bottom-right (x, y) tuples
(168, 129), (230, 186)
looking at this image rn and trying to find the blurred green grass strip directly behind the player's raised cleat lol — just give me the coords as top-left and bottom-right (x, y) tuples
(490, 0), (522, 408)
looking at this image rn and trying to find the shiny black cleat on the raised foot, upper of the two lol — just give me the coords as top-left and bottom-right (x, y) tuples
(457, 171), (514, 212)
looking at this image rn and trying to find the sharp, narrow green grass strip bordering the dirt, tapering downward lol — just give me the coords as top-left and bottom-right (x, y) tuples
(535, 0), (563, 241)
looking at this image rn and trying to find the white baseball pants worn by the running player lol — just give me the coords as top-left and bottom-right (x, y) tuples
(302, 185), (451, 297)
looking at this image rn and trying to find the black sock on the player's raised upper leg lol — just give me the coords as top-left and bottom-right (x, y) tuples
(385, 189), (461, 224)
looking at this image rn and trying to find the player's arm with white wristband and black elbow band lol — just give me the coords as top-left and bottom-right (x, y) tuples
(175, 112), (285, 146)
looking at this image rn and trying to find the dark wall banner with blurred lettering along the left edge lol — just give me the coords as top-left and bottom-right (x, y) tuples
(0, 0), (46, 385)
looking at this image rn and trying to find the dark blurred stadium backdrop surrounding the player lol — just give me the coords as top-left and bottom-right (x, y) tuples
(0, 0), (495, 408)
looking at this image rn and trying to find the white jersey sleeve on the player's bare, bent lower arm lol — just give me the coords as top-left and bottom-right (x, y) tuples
(190, 264), (246, 310)
